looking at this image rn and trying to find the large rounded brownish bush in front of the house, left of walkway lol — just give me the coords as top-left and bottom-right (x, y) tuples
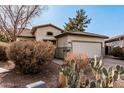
(8, 41), (55, 74)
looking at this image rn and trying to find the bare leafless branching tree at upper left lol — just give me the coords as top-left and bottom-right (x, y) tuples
(0, 5), (45, 42)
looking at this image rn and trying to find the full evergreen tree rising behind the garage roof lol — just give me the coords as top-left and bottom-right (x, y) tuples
(64, 9), (91, 31)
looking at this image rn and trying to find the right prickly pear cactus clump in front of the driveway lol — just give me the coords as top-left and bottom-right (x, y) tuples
(90, 57), (124, 88)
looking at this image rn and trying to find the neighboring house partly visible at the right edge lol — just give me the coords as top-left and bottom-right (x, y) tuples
(105, 35), (124, 54)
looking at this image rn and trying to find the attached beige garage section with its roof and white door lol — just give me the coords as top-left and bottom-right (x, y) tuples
(56, 32), (108, 58)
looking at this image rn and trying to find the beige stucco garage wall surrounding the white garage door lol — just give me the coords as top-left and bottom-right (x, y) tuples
(57, 35), (105, 55)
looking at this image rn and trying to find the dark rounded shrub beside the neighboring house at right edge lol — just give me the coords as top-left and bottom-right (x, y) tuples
(112, 47), (124, 57)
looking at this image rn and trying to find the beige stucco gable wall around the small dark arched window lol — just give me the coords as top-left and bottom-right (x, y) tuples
(35, 26), (61, 41)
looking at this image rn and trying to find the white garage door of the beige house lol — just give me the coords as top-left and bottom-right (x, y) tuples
(72, 42), (102, 58)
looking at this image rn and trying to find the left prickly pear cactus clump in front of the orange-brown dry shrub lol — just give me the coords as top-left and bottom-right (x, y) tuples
(58, 61), (83, 88)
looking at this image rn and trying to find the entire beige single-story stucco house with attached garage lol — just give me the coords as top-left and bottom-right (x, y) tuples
(18, 24), (108, 58)
